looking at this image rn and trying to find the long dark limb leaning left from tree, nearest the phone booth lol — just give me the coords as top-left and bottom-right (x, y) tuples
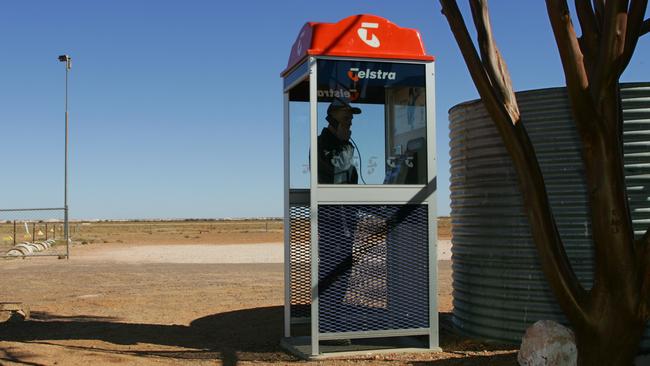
(440, 0), (587, 325)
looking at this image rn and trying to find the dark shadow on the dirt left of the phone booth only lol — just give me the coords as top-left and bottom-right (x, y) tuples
(0, 306), (288, 365)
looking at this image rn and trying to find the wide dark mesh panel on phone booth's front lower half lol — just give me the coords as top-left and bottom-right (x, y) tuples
(318, 205), (429, 333)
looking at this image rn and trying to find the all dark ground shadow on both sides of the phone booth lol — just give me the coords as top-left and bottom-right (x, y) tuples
(0, 306), (516, 366)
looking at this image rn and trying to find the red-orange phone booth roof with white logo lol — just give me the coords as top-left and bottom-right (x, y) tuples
(282, 14), (433, 76)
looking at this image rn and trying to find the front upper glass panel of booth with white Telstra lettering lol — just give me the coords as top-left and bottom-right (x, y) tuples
(314, 60), (427, 185)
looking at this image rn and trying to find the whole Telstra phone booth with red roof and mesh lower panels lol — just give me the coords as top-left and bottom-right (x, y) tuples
(282, 15), (439, 358)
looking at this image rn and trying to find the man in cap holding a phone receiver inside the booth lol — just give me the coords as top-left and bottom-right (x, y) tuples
(318, 99), (361, 184)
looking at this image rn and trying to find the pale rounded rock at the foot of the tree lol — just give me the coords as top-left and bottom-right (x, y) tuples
(517, 320), (578, 366)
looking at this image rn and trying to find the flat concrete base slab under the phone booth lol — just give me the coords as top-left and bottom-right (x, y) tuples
(280, 336), (442, 360)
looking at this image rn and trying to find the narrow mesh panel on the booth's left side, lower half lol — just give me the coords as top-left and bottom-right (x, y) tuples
(289, 206), (311, 318)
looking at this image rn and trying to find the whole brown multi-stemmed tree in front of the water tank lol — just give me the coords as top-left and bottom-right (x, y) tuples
(440, 0), (650, 366)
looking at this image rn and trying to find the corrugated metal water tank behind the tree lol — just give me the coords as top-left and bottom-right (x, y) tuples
(449, 83), (650, 349)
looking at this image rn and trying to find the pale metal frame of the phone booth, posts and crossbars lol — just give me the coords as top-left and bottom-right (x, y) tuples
(283, 56), (439, 356)
